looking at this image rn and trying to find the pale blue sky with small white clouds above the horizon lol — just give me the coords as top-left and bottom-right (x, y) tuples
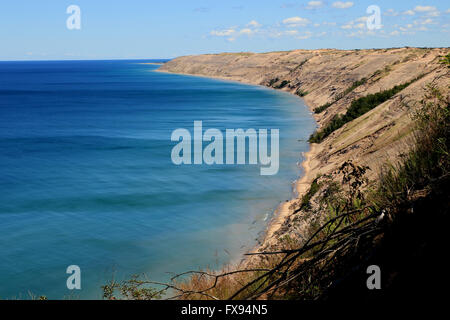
(0, 0), (450, 60)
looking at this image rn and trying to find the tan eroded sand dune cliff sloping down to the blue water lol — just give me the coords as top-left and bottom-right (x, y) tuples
(160, 48), (450, 249)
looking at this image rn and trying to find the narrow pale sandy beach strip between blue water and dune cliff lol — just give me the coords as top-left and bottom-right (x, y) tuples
(156, 69), (318, 256)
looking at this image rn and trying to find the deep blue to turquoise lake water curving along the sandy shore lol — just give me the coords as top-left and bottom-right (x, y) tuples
(0, 61), (315, 299)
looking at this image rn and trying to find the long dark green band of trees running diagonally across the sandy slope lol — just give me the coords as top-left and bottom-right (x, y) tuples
(308, 78), (418, 143)
